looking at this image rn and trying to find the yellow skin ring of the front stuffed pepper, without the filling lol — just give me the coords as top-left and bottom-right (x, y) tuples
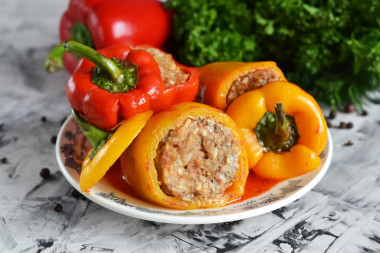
(120, 102), (248, 209)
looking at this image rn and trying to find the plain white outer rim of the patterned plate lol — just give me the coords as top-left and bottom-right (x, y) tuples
(55, 115), (333, 224)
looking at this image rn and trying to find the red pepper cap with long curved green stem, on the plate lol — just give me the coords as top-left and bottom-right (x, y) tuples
(63, 41), (164, 131)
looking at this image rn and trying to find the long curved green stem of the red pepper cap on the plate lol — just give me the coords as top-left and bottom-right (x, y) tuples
(62, 40), (124, 84)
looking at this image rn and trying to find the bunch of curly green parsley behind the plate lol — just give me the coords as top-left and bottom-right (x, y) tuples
(166, 0), (380, 108)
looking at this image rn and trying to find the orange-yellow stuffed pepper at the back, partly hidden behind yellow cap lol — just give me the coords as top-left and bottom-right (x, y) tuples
(198, 62), (286, 111)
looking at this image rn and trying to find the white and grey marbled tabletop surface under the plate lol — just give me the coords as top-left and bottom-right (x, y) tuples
(0, 0), (380, 252)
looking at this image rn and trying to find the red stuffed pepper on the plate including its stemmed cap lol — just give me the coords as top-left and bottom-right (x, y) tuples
(63, 41), (199, 131)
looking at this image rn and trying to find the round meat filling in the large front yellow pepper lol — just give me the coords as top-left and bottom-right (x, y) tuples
(155, 118), (240, 201)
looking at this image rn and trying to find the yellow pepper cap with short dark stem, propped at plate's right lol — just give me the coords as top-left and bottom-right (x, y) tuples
(226, 82), (327, 179)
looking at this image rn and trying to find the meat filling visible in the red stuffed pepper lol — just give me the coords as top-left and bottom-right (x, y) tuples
(136, 47), (189, 87)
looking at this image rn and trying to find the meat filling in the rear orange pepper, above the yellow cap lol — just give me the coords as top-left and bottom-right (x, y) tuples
(226, 68), (282, 105)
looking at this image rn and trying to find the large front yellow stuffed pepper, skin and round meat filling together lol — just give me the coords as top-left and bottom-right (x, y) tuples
(121, 103), (248, 209)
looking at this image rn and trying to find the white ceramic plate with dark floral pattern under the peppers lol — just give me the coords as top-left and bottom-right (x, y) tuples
(56, 117), (332, 224)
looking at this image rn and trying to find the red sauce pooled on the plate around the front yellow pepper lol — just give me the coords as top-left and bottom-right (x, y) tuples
(103, 160), (281, 204)
